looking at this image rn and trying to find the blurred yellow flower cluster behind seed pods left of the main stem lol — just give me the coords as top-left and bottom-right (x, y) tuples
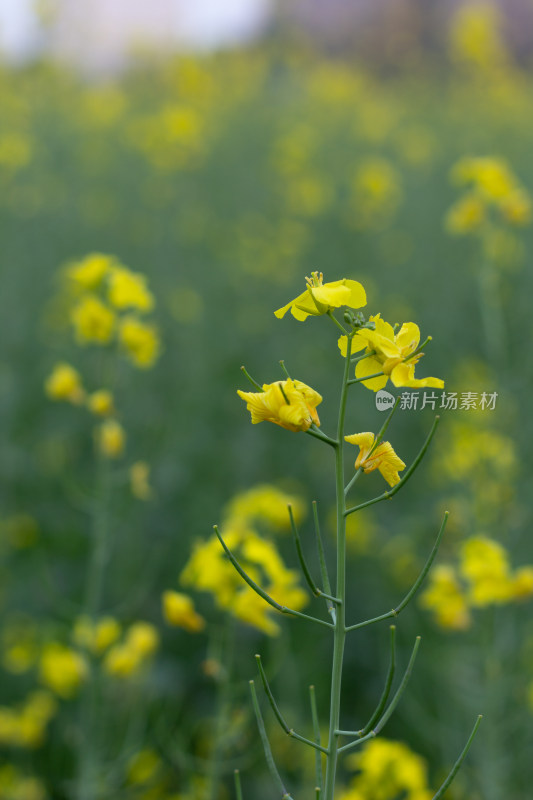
(174, 484), (307, 636)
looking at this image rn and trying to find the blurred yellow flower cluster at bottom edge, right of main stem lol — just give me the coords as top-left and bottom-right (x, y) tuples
(339, 737), (433, 800)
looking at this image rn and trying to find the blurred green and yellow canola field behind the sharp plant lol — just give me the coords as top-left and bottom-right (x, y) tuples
(0, 6), (533, 800)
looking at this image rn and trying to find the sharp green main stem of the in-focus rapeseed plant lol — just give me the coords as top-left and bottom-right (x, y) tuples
(324, 335), (352, 800)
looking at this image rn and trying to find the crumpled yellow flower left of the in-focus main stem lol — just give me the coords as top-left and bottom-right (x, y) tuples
(237, 378), (322, 432)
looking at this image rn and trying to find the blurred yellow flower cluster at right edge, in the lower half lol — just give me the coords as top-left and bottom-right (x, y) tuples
(420, 536), (533, 630)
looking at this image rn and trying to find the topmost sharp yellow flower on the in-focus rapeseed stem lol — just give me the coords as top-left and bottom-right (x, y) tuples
(274, 272), (366, 322)
